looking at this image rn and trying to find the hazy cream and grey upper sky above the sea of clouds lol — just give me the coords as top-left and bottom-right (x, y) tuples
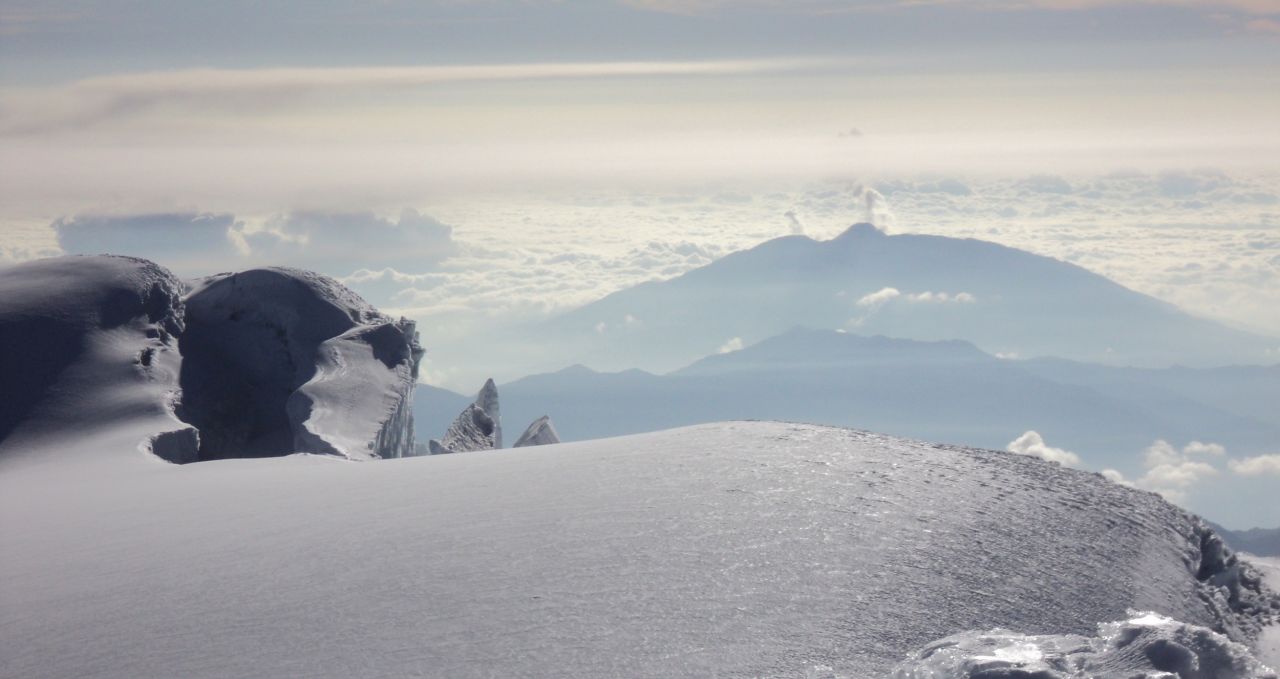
(0, 0), (1280, 211)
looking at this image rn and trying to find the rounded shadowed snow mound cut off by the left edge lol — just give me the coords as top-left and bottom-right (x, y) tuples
(0, 255), (192, 459)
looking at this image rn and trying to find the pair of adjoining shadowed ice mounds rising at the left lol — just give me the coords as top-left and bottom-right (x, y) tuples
(0, 255), (422, 462)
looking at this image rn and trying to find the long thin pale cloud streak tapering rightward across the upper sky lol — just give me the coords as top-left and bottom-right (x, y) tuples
(0, 59), (835, 136)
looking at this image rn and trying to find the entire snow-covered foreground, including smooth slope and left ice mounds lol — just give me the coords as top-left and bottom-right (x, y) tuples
(0, 252), (1280, 679)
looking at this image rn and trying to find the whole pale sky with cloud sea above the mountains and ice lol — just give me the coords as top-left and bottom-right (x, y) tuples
(0, 0), (1280, 515)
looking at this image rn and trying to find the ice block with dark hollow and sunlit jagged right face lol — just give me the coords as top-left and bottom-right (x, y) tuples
(179, 268), (422, 460)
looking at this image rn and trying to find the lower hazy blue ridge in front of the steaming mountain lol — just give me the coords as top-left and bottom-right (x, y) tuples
(416, 328), (1280, 465)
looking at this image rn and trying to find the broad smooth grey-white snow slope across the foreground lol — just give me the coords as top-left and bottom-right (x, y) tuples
(0, 423), (1275, 679)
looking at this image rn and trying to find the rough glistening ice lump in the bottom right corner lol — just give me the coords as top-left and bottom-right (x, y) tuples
(893, 611), (1276, 679)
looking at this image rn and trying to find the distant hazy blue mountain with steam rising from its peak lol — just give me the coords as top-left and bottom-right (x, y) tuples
(527, 224), (1280, 372)
